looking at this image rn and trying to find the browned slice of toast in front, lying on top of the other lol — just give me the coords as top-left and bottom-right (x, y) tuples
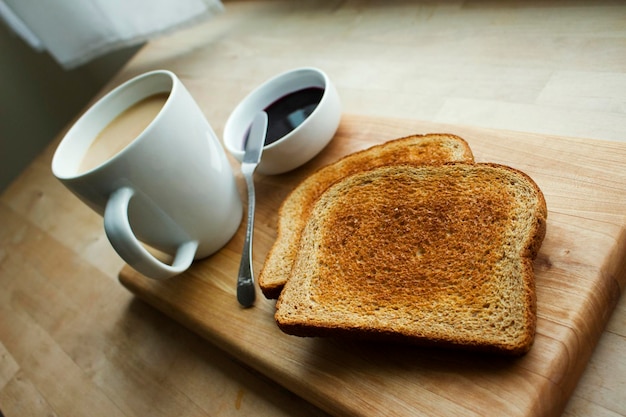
(275, 163), (547, 354)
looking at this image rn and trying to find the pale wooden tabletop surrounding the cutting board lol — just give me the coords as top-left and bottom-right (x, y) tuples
(0, 0), (626, 417)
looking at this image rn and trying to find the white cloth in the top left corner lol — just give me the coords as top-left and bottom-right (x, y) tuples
(0, 0), (223, 69)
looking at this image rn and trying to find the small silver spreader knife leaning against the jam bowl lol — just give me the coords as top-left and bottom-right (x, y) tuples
(237, 111), (267, 307)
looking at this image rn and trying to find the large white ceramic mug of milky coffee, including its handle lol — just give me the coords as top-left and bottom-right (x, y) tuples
(52, 70), (243, 279)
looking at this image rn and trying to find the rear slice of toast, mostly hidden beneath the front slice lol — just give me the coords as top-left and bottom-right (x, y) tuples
(258, 133), (474, 299)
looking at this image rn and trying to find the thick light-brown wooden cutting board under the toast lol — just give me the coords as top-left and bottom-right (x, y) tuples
(120, 115), (626, 416)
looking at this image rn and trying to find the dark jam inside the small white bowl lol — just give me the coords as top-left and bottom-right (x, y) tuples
(246, 87), (324, 145)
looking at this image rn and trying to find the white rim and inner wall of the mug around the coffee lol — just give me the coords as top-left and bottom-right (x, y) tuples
(51, 69), (177, 180)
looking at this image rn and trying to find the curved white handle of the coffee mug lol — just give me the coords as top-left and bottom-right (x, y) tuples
(104, 187), (198, 280)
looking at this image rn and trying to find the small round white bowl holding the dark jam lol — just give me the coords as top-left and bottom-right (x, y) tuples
(224, 68), (341, 175)
